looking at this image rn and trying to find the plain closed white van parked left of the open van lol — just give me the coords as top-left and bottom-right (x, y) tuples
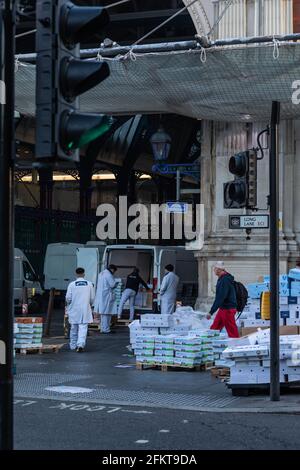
(44, 243), (84, 298)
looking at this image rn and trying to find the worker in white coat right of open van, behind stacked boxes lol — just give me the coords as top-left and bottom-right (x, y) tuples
(160, 264), (179, 315)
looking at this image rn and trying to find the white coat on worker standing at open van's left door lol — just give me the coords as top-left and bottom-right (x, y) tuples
(94, 269), (117, 315)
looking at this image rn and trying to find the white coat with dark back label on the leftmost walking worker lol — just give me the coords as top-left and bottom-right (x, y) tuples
(66, 277), (95, 324)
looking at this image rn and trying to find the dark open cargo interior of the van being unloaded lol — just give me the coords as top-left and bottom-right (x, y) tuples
(107, 248), (153, 283)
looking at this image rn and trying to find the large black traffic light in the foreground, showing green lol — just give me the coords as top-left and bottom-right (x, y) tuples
(36, 0), (114, 161)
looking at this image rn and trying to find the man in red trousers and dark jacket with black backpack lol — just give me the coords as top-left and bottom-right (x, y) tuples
(207, 261), (239, 338)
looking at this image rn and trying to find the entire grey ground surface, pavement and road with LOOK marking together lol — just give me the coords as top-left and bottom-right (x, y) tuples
(15, 317), (300, 450)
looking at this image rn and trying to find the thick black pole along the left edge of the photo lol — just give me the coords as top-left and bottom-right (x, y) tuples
(0, 0), (15, 450)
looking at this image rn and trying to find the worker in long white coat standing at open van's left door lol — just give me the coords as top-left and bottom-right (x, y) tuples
(94, 264), (117, 334)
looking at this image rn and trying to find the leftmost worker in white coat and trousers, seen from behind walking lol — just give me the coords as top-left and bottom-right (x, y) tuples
(66, 268), (95, 352)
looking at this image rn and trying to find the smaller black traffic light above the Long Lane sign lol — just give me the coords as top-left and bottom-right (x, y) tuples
(224, 150), (257, 209)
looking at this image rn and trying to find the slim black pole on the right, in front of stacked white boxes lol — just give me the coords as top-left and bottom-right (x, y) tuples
(270, 101), (280, 401)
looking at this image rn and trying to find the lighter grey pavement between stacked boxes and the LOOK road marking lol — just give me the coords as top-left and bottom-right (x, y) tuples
(15, 314), (300, 414)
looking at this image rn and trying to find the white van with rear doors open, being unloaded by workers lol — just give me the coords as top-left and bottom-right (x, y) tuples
(77, 245), (198, 312)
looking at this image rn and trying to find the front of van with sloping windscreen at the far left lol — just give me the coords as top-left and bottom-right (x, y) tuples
(14, 248), (43, 309)
